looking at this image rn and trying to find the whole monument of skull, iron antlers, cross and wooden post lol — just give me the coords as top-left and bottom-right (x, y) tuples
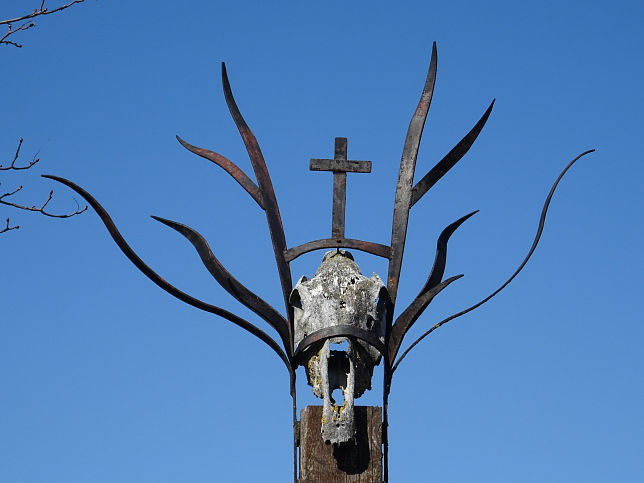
(44, 44), (592, 483)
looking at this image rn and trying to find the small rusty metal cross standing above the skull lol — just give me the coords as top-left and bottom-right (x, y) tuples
(309, 138), (371, 241)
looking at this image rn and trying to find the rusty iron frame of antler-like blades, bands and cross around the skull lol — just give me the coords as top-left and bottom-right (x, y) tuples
(43, 43), (594, 482)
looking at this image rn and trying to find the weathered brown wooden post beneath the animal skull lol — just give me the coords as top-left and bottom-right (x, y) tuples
(299, 406), (382, 483)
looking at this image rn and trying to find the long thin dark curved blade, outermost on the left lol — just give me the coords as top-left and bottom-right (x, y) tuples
(42, 174), (292, 373)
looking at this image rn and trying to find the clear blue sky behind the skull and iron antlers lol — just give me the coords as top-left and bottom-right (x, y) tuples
(0, 0), (644, 483)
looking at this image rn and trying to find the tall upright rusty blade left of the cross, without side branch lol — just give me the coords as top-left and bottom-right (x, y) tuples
(221, 62), (293, 338)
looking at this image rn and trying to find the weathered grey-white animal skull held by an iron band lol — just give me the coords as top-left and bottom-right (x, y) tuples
(291, 250), (387, 444)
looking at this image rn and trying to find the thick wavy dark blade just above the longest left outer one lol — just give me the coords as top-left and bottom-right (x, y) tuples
(152, 215), (290, 352)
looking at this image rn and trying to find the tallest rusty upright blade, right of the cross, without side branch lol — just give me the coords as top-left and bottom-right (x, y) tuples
(387, 42), (438, 304)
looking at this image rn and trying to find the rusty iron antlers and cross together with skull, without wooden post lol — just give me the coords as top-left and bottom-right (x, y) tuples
(43, 43), (594, 481)
